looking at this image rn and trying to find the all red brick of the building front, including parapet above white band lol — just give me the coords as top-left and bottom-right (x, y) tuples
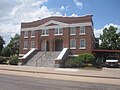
(20, 16), (95, 54)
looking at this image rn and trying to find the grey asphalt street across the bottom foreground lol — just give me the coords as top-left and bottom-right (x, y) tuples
(0, 74), (120, 90)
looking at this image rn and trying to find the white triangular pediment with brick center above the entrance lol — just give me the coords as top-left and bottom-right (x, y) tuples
(39, 20), (68, 28)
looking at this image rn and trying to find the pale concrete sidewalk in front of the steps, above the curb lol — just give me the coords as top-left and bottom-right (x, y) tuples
(0, 65), (120, 79)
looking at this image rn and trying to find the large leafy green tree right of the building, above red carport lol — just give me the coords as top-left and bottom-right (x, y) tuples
(100, 26), (120, 50)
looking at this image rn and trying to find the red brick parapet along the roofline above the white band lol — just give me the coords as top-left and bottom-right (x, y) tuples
(21, 15), (93, 28)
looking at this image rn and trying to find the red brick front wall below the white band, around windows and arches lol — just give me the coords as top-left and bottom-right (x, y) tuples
(20, 26), (93, 54)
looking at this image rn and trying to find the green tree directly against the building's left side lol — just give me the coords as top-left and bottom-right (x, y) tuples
(7, 34), (20, 56)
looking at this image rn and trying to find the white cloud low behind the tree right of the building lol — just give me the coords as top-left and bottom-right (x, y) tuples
(94, 23), (120, 37)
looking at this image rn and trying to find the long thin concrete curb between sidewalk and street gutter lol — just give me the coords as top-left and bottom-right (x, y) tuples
(0, 67), (120, 79)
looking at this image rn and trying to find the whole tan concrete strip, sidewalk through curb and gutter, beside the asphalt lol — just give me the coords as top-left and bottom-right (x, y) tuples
(0, 65), (120, 85)
